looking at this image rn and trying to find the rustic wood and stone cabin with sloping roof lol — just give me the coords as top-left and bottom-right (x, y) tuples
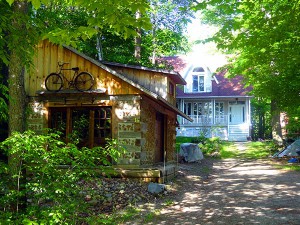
(25, 40), (191, 182)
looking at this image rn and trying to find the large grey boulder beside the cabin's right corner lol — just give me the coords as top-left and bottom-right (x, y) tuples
(179, 143), (204, 162)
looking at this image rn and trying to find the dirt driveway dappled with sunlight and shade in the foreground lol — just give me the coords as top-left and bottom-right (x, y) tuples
(127, 156), (300, 225)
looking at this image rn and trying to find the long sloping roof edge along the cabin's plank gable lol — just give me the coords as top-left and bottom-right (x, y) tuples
(63, 45), (193, 121)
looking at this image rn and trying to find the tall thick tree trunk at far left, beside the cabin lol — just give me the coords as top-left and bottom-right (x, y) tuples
(8, 1), (29, 211)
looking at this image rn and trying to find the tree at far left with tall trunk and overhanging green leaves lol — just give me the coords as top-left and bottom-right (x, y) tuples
(0, 0), (149, 211)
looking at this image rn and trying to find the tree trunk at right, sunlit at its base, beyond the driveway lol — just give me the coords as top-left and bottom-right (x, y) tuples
(271, 100), (283, 145)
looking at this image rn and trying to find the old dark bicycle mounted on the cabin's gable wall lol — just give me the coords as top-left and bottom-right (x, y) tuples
(45, 62), (94, 92)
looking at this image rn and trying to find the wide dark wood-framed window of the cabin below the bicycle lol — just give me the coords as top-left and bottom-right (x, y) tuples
(49, 107), (112, 148)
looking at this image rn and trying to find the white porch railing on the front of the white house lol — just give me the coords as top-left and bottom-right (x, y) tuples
(179, 115), (228, 126)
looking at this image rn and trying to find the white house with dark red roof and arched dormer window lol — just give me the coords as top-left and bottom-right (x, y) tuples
(166, 57), (252, 141)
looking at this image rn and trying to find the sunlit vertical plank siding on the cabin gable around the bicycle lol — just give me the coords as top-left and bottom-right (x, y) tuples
(25, 41), (141, 96)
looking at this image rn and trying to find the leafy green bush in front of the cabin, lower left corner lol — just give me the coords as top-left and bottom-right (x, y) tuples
(0, 131), (122, 224)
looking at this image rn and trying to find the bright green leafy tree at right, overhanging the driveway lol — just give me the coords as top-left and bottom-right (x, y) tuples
(195, 0), (300, 142)
